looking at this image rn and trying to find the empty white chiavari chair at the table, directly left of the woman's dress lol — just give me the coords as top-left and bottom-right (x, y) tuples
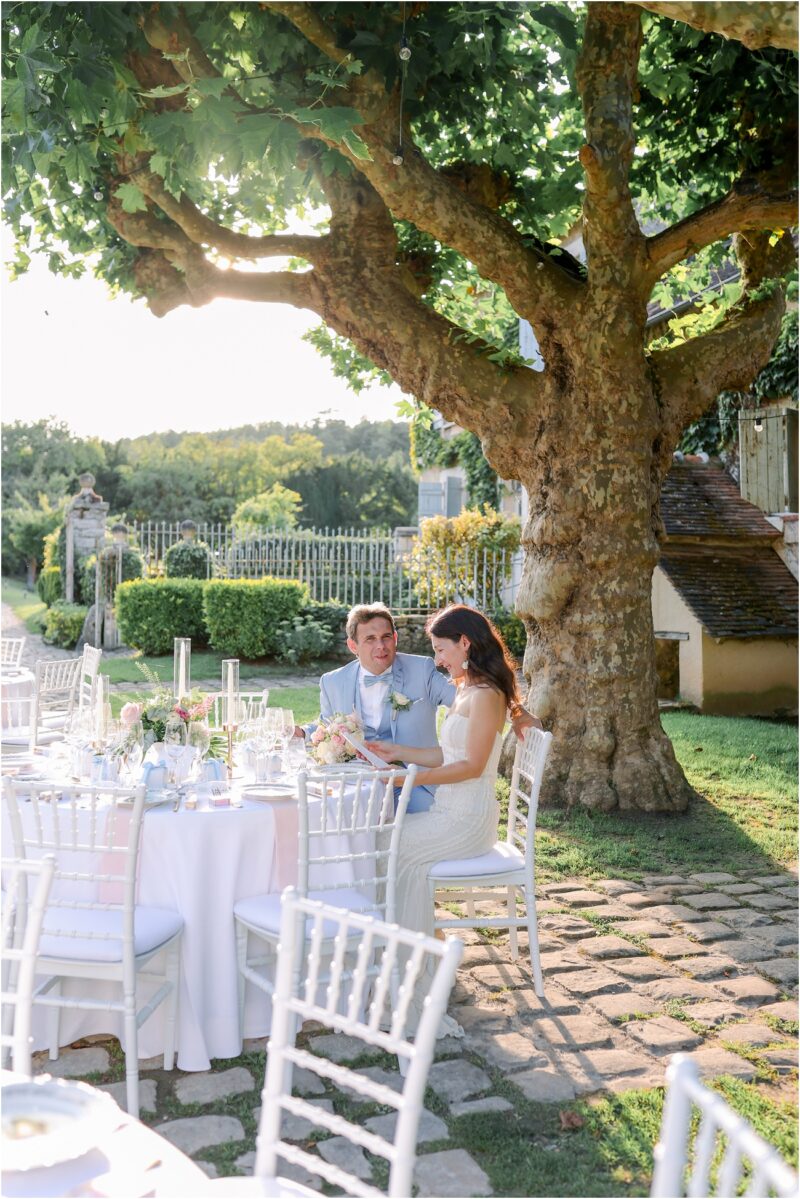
(234, 766), (416, 1028)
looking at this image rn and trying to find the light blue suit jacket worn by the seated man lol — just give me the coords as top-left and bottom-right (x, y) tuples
(319, 653), (456, 812)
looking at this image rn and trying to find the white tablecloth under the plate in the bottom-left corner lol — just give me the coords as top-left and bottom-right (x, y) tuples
(0, 1071), (207, 1199)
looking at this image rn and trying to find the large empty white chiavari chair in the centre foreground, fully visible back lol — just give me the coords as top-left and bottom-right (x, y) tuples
(210, 888), (463, 1199)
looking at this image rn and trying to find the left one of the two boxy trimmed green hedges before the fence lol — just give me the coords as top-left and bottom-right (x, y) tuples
(115, 579), (207, 653)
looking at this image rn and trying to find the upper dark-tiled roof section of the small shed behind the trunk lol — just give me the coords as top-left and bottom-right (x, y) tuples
(661, 459), (781, 542)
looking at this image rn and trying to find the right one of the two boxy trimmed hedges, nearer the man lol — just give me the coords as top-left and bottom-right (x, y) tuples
(203, 578), (308, 658)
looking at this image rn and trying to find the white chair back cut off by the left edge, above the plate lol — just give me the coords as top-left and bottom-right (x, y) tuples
(0, 855), (55, 1074)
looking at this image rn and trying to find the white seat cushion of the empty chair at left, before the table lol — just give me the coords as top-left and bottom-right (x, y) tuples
(38, 906), (184, 962)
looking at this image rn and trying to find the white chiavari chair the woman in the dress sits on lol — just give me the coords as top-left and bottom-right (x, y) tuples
(428, 729), (553, 996)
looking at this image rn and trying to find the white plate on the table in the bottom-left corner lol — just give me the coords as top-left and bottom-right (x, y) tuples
(2, 1078), (124, 1171)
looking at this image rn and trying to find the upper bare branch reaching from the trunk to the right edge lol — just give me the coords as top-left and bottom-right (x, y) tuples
(646, 179), (798, 285)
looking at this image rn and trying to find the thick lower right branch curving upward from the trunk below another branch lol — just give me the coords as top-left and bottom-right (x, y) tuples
(650, 233), (795, 445)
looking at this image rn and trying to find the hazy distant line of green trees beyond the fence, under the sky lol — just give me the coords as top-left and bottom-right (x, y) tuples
(1, 418), (416, 573)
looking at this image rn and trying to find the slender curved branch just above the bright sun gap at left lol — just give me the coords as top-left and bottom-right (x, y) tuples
(133, 169), (326, 263)
